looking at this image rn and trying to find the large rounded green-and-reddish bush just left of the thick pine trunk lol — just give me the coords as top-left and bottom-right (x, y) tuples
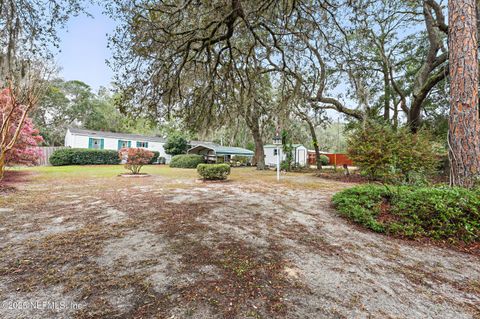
(348, 122), (442, 184)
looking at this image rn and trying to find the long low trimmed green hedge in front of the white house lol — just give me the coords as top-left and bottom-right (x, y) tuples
(49, 148), (120, 166)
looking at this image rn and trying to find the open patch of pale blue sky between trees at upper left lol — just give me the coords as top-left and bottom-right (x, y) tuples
(56, 6), (116, 91)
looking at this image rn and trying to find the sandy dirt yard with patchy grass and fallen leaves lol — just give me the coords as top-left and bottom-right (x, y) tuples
(0, 167), (480, 319)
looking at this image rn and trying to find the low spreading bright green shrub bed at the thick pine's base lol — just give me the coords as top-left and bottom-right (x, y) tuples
(333, 185), (480, 243)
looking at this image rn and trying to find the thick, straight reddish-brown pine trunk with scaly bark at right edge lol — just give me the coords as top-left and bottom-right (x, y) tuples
(448, 0), (480, 187)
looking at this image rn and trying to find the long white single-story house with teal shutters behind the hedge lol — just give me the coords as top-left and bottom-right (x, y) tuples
(65, 128), (171, 163)
